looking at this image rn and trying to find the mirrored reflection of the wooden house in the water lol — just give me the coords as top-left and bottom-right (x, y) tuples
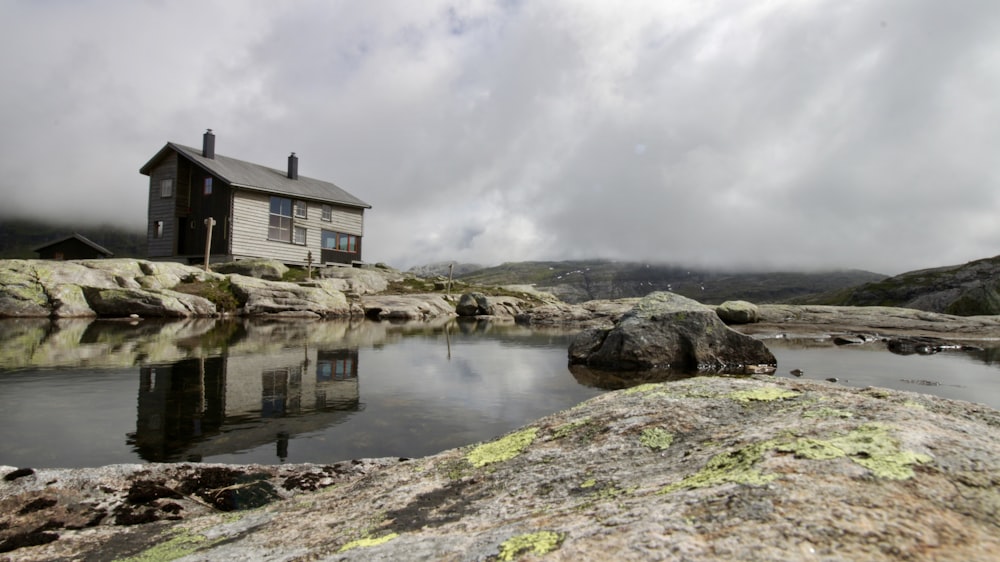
(131, 348), (361, 461)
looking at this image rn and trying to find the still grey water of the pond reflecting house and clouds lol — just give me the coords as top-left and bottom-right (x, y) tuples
(0, 320), (1000, 468)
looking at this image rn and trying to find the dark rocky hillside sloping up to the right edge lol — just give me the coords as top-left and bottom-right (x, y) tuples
(799, 256), (1000, 316)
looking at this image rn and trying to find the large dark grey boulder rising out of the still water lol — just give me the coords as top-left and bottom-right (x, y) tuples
(569, 292), (777, 372)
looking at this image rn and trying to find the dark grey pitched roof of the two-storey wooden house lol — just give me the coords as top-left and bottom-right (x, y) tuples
(139, 142), (371, 209)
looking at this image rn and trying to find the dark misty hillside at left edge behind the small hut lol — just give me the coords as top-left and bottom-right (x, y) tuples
(0, 217), (146, 259)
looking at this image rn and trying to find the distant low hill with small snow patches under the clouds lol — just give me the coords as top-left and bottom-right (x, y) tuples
(460, 260), (885, 304)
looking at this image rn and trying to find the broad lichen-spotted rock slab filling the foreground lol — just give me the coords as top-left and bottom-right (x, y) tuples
(0, 377), (1000, 562)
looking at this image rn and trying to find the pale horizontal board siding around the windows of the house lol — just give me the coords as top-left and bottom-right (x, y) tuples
(230, 190), (364, 265)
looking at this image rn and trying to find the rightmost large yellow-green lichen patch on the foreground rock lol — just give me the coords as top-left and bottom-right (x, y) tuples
(775, 424), (933, 480)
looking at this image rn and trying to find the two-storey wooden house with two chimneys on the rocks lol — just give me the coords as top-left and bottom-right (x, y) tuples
(139, 129), (371, 265)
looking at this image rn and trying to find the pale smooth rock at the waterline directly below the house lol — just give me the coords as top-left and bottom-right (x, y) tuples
(229, 274), (351, 317)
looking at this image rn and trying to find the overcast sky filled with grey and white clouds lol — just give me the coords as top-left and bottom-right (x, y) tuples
(0, 0), (1000, 274)
